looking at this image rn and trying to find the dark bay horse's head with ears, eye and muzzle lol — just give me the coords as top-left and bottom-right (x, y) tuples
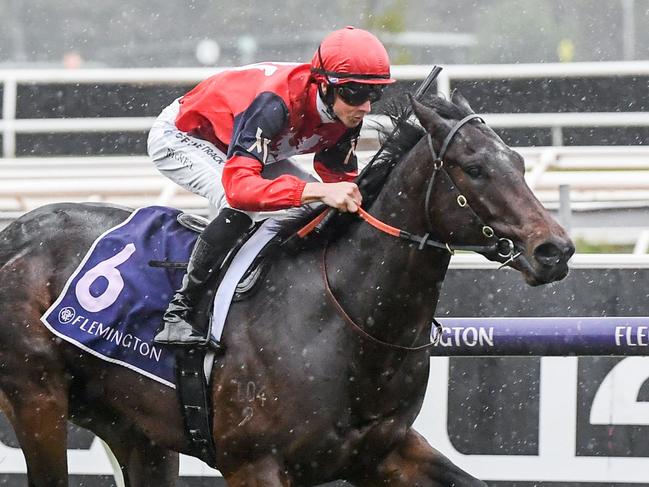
(412, 93), (575, 285)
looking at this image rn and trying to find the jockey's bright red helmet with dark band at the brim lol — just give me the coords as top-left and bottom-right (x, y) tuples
(311, 26), (396, 85)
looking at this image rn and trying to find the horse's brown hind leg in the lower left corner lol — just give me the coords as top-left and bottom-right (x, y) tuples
(9, 382), (68, 487)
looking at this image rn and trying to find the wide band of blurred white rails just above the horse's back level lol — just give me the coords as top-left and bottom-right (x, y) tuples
(0, 146), (649, 211)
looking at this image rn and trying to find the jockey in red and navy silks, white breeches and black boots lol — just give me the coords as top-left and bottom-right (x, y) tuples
(148, 27), (395, 345)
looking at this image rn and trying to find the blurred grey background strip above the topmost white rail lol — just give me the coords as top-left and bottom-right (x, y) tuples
(0, 0), (649, 68)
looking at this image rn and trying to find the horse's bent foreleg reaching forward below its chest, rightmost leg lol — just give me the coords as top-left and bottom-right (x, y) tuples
(350, 429), (487, 487)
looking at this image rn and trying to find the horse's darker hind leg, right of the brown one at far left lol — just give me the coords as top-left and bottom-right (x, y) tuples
(97, 431), (179, 487)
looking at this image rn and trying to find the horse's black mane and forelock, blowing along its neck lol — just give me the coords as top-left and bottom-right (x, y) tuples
(278, 96), (469, 252)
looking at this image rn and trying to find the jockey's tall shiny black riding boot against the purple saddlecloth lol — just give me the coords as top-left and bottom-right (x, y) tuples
(154, 208), (252, 349)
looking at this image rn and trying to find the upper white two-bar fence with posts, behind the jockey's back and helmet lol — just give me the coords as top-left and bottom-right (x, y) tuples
(0, 61), (649, 157)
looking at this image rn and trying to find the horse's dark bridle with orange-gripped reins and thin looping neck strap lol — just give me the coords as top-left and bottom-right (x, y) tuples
(298, 113), (521, 352)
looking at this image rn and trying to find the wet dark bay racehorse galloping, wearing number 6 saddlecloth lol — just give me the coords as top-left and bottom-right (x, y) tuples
(0, 95), (574, 487)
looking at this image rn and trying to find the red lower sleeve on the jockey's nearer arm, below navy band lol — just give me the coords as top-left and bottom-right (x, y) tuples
(222, 155), (306, 211)
